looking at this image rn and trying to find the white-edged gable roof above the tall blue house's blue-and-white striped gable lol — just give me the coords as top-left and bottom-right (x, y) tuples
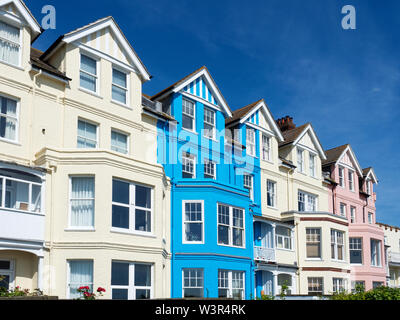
(151, 66), (232, 117)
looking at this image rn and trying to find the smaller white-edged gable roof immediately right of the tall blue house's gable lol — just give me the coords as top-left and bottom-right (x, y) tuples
(225, 99), (284, 142)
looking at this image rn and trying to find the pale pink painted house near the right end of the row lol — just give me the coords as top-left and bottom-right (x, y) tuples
(322, 144), (386, 290)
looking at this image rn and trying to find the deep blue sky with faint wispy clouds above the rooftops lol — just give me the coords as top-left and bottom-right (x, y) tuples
(26, 0), (400, 225)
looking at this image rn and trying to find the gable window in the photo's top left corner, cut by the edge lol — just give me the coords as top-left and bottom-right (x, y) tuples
(0, 21), (21, 66)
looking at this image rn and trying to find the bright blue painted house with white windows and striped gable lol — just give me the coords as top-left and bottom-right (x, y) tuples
(151, 67), (255, 299)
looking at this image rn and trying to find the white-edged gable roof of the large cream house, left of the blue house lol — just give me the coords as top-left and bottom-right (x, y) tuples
(41, 16), (151, 81)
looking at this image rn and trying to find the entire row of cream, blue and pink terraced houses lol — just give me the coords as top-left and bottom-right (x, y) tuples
(0, 0), (390, 299)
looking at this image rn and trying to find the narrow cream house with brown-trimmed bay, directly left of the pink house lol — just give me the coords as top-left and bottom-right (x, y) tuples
(277, 117), (350, 295)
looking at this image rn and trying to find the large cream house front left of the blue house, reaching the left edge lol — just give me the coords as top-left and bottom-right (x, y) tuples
(0, 0), (170, 299)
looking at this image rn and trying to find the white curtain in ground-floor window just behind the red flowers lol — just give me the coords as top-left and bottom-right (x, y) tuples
(69, 261), (93, 299)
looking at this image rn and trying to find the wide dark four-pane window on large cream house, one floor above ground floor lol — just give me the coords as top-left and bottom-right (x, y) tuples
(112, 179), (153, 233)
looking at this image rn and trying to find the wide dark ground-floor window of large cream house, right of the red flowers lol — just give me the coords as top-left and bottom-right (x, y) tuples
(111, 261), (153, 300)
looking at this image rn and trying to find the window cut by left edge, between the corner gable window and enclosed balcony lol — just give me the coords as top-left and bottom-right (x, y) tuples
(0, 96), (18, 141)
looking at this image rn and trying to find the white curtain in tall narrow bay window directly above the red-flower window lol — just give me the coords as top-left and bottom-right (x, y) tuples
(71, 177), (94, 227)
